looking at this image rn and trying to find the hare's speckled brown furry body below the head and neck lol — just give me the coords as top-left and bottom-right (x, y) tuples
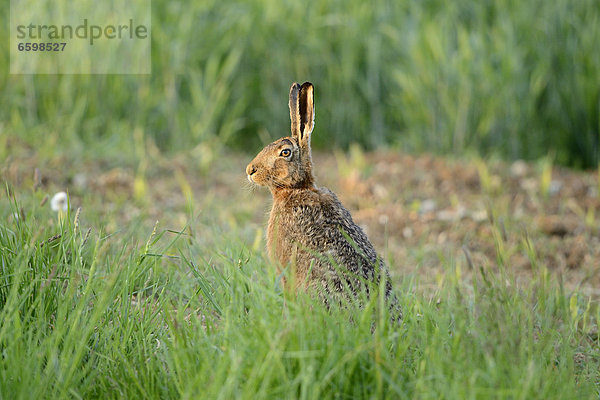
(267, 188), (390, 294)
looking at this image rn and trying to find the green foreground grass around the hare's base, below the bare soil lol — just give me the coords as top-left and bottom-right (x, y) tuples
(0, 183), (600, 399)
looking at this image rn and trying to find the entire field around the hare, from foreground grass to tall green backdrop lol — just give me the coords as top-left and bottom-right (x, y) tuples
(0, 0), (600, 399)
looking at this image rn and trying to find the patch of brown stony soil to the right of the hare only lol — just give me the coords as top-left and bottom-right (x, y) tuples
(317, 152), (600, 297)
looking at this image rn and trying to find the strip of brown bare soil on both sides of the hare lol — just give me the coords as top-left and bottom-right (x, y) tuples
(1, 149), (600, 297)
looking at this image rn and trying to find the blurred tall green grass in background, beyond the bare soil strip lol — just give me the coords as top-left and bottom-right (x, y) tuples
(0, 0), (600, 167)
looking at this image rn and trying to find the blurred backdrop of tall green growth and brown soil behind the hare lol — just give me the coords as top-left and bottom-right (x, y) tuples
(0, 0), (600, 293)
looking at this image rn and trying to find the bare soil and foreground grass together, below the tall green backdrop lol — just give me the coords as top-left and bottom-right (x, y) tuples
(0, 147), (600, 399)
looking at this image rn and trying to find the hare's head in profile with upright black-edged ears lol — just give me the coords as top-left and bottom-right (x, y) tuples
(246, 82), (315, 191)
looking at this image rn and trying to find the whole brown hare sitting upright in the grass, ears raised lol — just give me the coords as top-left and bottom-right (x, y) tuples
(246, 82), (391, 303)
